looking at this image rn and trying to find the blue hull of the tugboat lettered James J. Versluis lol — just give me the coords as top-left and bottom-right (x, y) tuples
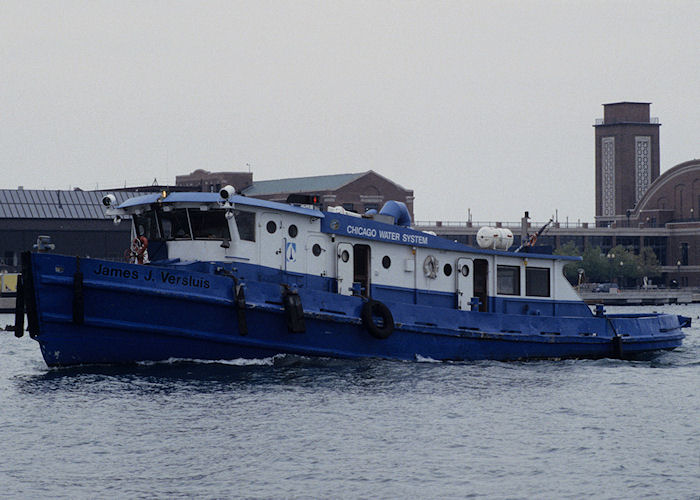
(23, 254), (684, 366)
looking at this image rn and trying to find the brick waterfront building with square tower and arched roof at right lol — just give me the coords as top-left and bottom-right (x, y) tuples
(416, 102), (700, 287)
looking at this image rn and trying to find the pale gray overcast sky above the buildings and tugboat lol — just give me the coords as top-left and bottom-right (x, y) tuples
(0, 0), (700, 221)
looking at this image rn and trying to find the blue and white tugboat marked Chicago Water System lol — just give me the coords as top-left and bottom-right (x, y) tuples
(15, 186), (690, 366)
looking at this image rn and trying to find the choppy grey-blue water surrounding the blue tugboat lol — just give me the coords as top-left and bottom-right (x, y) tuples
(0, 306), (700, 499)
